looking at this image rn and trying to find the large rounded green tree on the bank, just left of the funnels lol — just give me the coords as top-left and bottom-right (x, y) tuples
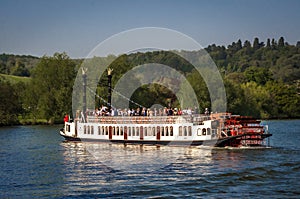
(24, 53), (76, 122)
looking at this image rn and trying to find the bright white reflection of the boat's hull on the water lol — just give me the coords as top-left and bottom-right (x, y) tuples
(62, 142), (216, 173)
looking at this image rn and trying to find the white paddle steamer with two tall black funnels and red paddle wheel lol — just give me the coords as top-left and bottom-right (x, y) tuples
(60, 69), (272, 147)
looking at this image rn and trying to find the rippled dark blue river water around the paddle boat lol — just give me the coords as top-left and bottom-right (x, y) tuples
(0, 120), (300, 198)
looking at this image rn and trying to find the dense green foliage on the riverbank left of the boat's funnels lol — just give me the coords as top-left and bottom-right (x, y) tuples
(0, 53), (76, 125)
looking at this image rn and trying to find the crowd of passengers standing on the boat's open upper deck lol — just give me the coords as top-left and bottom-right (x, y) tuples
(92, 106), (209, 116)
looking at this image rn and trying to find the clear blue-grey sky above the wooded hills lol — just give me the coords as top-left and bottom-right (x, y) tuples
(0, 0), (300, 58)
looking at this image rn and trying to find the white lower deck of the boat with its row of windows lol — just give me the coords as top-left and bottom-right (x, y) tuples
(65, 121), (217, 143)
